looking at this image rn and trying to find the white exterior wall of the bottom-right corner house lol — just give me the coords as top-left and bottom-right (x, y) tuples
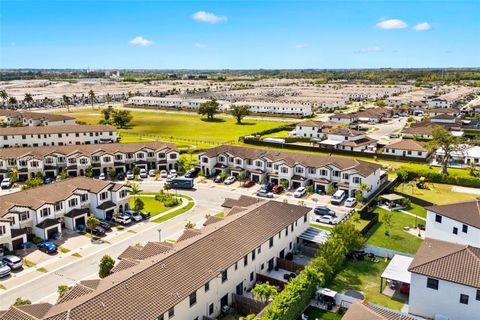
(408, 273), (480, 320)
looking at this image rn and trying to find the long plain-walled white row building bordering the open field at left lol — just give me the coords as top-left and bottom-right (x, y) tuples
(0, 124), (118, 148)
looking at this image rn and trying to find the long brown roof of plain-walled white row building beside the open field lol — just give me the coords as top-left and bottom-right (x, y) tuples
(0, 124), (117, 136)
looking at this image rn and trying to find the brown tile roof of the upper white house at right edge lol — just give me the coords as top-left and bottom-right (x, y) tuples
(426, 199), (480, 229)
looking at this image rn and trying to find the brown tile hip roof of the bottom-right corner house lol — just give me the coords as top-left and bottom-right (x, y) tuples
(408, 238), (480, 289)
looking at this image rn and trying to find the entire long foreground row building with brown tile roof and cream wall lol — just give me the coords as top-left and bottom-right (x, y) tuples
(2, 201), (311, 320)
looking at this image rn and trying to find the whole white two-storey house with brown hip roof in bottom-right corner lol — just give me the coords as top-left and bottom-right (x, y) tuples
(408, 238), (480, 320)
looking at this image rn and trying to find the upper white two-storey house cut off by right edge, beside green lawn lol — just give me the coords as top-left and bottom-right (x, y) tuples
(426, 199), (480, 247)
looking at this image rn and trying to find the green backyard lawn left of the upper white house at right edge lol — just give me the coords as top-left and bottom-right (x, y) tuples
(365, 208), (423, 254)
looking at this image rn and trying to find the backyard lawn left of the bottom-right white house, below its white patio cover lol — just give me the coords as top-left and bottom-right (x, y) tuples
(327, 259), (404, 310)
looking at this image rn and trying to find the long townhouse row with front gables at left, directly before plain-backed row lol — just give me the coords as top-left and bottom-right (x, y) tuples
(0, 141), (179, 181)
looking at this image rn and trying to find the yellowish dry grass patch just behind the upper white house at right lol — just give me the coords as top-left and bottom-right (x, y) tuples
(395, 182), (478, 204)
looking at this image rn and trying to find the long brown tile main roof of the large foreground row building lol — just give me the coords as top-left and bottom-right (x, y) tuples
(33, 201), (310, 320)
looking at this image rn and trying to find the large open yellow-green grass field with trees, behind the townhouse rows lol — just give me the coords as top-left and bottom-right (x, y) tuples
(58, 109), (286, 148)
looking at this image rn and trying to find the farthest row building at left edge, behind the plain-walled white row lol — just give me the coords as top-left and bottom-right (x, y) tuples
(0, 109), (76, 127)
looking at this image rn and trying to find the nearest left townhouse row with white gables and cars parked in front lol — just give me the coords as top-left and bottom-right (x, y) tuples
(0, 177), (130, 249)
